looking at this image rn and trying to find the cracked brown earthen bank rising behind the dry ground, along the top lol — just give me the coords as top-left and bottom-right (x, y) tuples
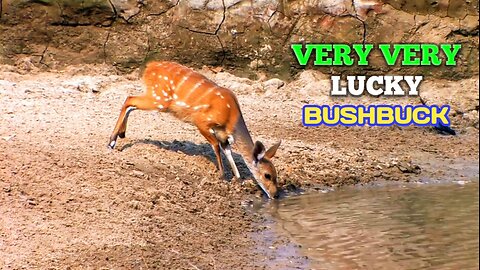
(0, 0), (479, 79)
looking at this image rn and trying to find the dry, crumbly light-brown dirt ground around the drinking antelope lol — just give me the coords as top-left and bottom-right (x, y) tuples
(0, 62), (479, 269)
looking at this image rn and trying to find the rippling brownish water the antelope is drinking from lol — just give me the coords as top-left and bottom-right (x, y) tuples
(265, 182), (479, 269)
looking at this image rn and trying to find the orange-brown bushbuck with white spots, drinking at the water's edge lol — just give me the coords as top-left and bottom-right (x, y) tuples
(108, 62), (280, 198)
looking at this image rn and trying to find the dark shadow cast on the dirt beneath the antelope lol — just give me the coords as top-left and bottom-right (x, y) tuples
(121, 139), (253, 179)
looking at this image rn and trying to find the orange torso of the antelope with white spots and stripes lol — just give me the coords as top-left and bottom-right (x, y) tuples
(143, 62), (241, 133)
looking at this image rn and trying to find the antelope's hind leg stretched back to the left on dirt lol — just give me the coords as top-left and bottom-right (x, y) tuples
(108, 96), (156, 149)
